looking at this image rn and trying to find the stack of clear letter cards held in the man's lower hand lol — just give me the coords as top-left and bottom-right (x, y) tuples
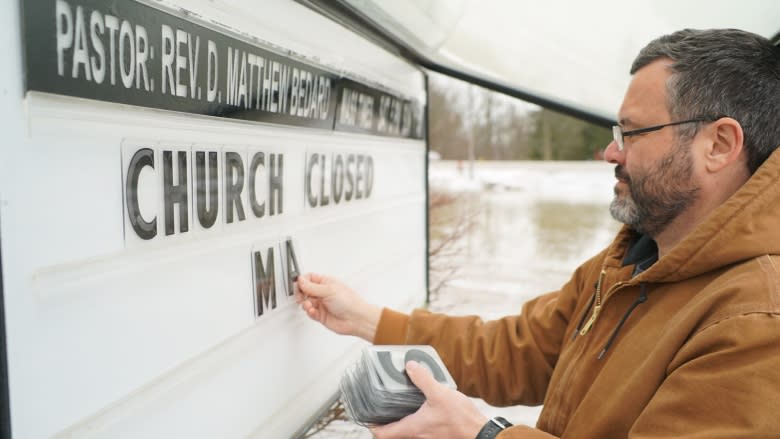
(340, 346), (457, 426)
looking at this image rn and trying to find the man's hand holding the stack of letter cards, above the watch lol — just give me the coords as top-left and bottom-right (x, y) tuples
(372, 361), (488, 439)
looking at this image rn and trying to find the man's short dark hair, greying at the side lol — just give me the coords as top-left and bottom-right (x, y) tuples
(631, 29), (780, 174)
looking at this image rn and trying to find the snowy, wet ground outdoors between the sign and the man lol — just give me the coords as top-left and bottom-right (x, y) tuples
(310, 161), (619, 439)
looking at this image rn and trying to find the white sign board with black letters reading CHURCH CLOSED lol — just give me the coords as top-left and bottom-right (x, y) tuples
(0, 0), (426, 438)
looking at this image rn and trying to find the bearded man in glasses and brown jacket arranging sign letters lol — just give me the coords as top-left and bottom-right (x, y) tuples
(299, 30), (780, 439)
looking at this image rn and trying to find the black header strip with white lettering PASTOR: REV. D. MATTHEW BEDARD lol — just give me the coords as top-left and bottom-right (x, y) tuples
(22, 0), (423, 138)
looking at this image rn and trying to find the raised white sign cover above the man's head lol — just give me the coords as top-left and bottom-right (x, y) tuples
(318, 0), (780, 124)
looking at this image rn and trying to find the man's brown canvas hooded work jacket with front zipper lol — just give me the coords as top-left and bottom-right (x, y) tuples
(374, 150), (780, 439)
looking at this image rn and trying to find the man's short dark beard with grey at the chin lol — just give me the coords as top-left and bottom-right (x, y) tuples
(609, 144), (699, 237)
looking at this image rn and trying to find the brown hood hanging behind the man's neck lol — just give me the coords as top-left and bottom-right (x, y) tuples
(624, 148), (780, 282)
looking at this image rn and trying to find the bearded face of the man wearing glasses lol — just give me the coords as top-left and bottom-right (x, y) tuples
(608, 60), (699, 237)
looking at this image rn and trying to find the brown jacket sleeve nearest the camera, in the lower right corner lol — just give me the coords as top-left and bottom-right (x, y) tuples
(629, 313), (780, 439)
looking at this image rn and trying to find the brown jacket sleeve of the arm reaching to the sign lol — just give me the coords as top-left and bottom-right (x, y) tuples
(374, 258), (592, 406)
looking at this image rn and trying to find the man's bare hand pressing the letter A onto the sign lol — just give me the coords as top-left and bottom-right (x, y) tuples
(295, 273), (382, 342)
